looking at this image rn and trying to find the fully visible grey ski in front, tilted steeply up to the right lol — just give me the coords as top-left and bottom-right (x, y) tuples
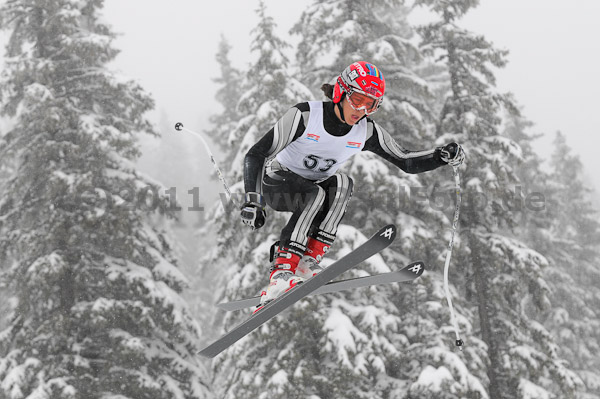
(198, 224), (396, 358)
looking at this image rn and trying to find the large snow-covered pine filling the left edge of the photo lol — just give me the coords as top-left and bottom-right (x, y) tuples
(0, 0), (210, 399)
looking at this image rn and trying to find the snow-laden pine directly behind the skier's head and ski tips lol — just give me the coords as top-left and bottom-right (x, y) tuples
(293, 0), (483, 397)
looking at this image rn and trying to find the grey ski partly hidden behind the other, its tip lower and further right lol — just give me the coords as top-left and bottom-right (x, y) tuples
(217, 262), (425, 312)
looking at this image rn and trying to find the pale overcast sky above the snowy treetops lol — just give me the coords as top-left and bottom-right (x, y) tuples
(1, 0), (600, 195)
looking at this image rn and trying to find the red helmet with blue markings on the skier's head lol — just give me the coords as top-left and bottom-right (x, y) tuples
(333, 61), (385, 114)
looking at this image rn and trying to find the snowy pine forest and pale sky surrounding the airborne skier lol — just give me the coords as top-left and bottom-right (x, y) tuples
(0, 0), (600, 399)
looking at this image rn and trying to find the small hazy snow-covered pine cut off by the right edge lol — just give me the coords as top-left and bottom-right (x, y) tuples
(539, 133), (600, 398)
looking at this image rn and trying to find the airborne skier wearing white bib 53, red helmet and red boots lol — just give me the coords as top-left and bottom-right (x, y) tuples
(241, 61), (464, 312)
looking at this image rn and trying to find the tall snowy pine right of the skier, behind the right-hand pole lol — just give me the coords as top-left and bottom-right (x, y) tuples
(416, 0), (578, 399)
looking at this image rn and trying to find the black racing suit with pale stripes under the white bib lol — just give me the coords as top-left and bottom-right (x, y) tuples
(244, 101), (446, 256)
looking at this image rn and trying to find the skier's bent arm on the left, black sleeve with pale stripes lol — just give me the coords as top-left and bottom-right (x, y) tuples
(244, 103), (310, 194)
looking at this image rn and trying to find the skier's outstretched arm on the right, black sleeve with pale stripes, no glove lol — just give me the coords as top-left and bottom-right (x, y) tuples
(363, 120), (447, 173)
